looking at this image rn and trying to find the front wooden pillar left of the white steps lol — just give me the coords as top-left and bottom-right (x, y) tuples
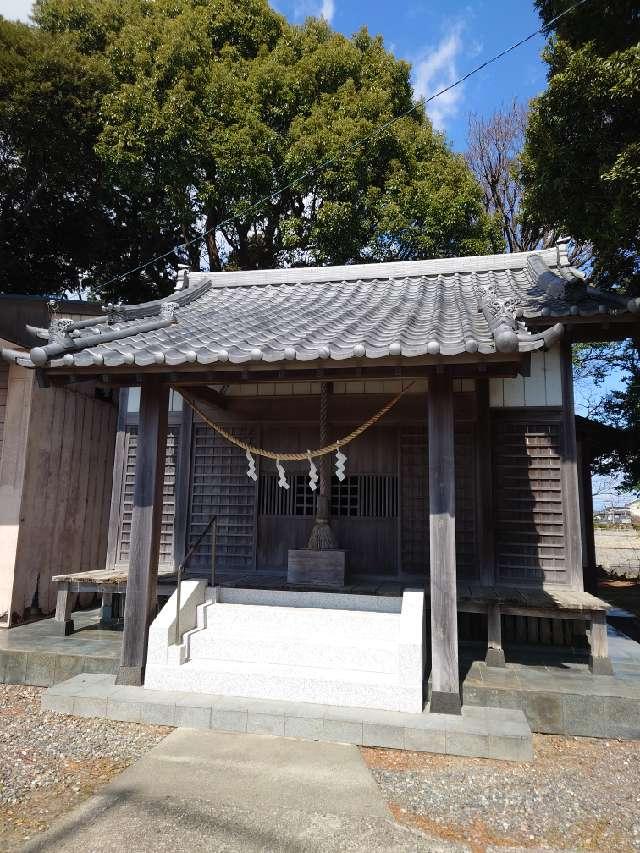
(116, 378), (169, 685)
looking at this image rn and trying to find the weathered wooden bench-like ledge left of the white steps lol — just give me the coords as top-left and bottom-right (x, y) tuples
(52, 566), (177, 637)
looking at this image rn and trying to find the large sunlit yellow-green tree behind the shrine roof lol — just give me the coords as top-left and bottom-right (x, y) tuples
(0, 0), (501, 298)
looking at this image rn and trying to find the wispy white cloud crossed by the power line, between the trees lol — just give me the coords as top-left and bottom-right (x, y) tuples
(414, 23), (464, 130)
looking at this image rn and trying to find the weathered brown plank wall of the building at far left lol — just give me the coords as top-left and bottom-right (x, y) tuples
(11, 383), (116, 622)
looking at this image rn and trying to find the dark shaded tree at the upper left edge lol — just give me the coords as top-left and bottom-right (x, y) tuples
(0, 14), (184, 302)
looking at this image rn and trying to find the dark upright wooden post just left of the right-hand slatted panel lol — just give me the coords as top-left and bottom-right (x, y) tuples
(475, 378), (496, 586)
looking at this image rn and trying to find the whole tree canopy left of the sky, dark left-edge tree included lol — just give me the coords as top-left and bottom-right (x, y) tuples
(0, 0), (501, 300)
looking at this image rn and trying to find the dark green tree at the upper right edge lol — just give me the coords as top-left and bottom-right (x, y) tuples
(523, 0), (640, 294)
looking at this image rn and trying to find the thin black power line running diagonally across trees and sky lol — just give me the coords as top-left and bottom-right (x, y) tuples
(101, 0), (591, 288)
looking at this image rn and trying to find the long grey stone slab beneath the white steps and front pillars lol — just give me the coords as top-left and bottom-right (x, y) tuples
(41, 675), (533, 764)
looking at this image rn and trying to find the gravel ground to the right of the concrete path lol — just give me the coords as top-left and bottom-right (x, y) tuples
(362, 735), (640, 853)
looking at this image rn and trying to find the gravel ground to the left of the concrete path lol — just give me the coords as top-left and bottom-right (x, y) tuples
(0, 684), (172, 853)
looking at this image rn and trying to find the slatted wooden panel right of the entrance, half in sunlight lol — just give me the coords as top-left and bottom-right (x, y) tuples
(493, 412), (566, 583)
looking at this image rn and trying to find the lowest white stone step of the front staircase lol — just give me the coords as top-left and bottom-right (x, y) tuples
(145, 659), (423, 713)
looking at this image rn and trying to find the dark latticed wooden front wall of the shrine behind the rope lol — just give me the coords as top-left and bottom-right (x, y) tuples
(110, 388), (572, 585)
